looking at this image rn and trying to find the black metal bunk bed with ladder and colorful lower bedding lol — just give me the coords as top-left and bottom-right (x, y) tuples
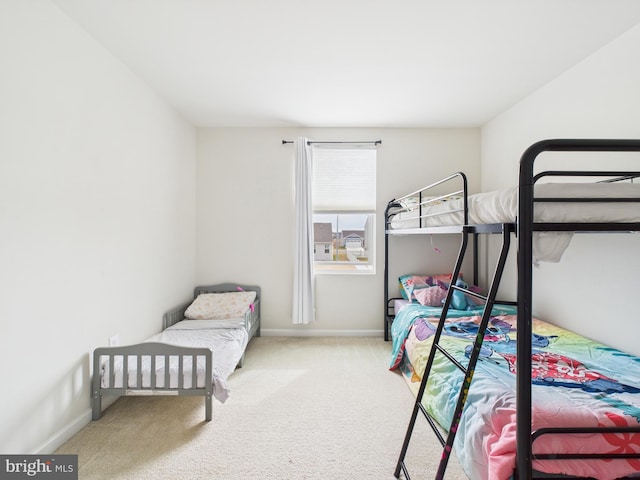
(384, 139), (640, 480)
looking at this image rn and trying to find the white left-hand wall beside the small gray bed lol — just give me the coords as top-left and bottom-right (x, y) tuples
(0, 0), (196, 453)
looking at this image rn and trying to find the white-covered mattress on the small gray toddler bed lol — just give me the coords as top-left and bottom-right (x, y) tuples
(102, 318), (249, 403)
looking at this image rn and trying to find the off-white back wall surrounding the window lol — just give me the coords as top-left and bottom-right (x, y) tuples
(197, 128), (480, 335)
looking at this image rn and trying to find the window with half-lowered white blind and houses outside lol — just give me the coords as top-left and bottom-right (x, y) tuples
(312, 144), (376, 273)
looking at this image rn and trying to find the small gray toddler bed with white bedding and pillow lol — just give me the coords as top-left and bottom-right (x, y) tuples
(92, 283), (260, 420)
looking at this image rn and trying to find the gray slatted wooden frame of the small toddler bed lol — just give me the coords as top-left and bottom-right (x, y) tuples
(91, 283), (261, 421)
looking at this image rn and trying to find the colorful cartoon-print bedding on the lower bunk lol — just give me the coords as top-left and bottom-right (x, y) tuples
(392, 306), (640, 480)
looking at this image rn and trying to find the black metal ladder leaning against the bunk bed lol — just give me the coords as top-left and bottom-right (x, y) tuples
(394, 224), (514, 480)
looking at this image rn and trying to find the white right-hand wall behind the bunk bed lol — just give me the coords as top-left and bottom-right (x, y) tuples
(482, 26), (640, 354)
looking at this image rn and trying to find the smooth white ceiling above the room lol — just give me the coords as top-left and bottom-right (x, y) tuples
(52, 0), (640, 127)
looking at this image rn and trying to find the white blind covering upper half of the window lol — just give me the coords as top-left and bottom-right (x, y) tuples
(312, 145), (376, 212)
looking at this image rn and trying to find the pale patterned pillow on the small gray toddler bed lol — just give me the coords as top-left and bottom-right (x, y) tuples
(184, 292), (256, 320)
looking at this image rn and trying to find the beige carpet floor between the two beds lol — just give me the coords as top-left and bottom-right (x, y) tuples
(56, 337), (467, 480)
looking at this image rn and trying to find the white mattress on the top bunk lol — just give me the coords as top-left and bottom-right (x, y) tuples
(390, 183), (640, 262)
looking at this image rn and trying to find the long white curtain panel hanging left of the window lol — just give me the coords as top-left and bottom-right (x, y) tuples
(292, 137), (315, 324)
